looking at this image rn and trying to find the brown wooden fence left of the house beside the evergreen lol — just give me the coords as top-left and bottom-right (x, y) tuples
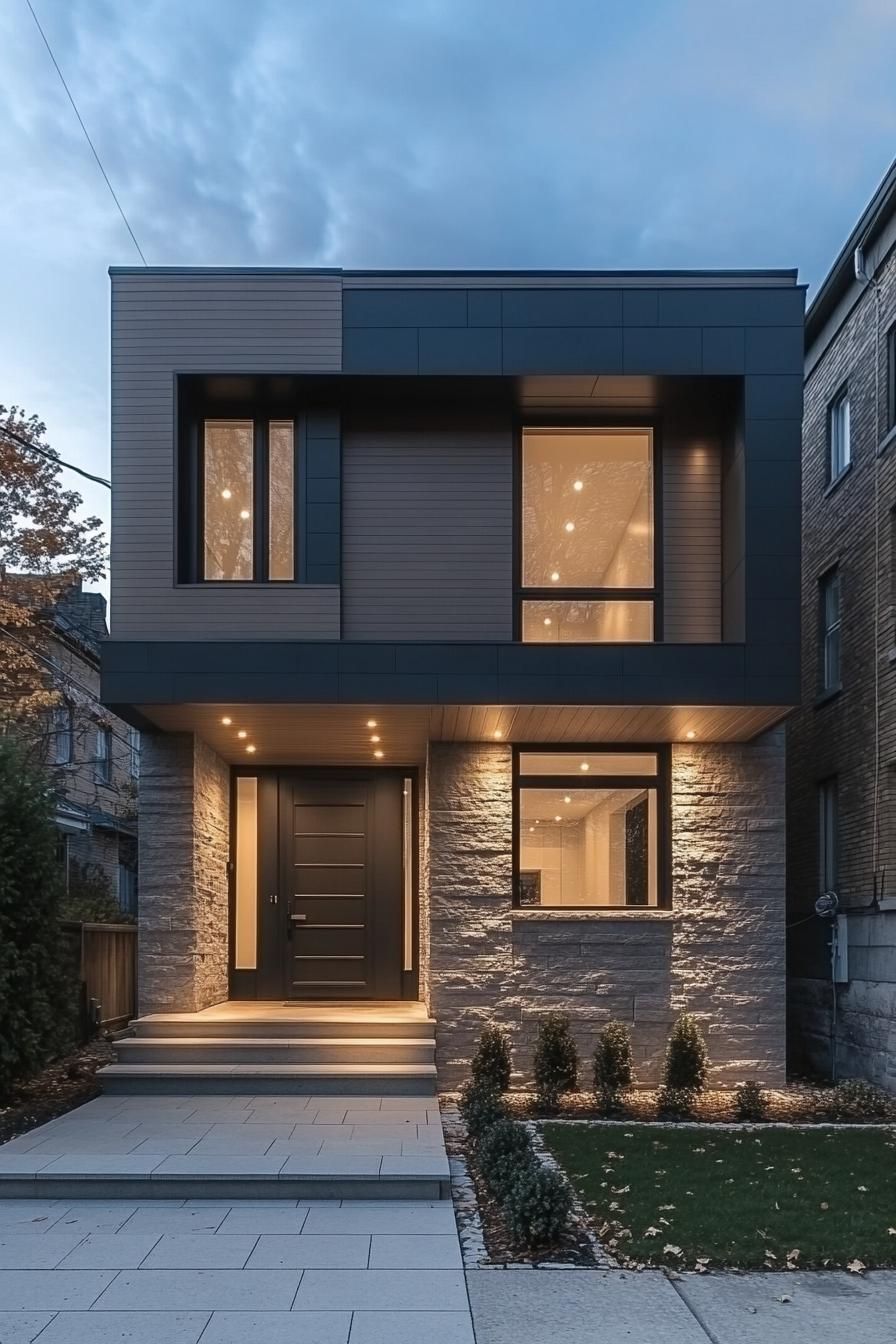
(62, 922), (137, 1038)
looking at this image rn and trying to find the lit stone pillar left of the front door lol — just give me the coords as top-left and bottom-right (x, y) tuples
(137, 734), (230, 1013)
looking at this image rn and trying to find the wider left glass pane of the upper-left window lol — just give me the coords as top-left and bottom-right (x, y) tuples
(203, 419), (254, 581)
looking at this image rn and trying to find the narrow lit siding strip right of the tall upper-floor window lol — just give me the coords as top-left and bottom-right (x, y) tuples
(662, 426), (721, 644)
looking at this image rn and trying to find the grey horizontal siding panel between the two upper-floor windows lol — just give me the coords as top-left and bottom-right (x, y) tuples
(343, 426), (513, 640)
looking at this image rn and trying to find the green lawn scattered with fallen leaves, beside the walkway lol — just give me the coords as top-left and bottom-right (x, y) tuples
(544, 1124), (896, 1269)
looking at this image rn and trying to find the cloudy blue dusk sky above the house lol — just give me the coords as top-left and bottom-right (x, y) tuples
(0, 0), (896, 569)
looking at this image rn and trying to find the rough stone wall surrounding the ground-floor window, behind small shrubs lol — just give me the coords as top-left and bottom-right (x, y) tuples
(427, 730), (785, 1087)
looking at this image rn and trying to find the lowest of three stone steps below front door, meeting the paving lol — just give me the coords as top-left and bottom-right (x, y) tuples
(97, 1063), (435, 1097)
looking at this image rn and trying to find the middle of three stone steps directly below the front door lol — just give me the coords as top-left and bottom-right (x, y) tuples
(116, 1035), (435, 1064)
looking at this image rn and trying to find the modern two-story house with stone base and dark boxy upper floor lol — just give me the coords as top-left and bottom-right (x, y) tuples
(102, 267), (805, 1090)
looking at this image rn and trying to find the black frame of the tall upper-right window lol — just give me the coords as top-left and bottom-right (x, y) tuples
(513, 414), (662, 648)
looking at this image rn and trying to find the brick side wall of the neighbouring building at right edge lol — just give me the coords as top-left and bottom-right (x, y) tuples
(787, 241), (896, 1090)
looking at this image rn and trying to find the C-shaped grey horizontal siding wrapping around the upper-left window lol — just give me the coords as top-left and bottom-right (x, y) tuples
(110, 273), (343, 640)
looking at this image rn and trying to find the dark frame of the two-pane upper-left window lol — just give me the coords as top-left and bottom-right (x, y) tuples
(177, 402), (304, 589)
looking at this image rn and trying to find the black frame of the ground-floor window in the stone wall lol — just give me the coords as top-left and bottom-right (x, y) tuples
(510, 742), (672, 918)
